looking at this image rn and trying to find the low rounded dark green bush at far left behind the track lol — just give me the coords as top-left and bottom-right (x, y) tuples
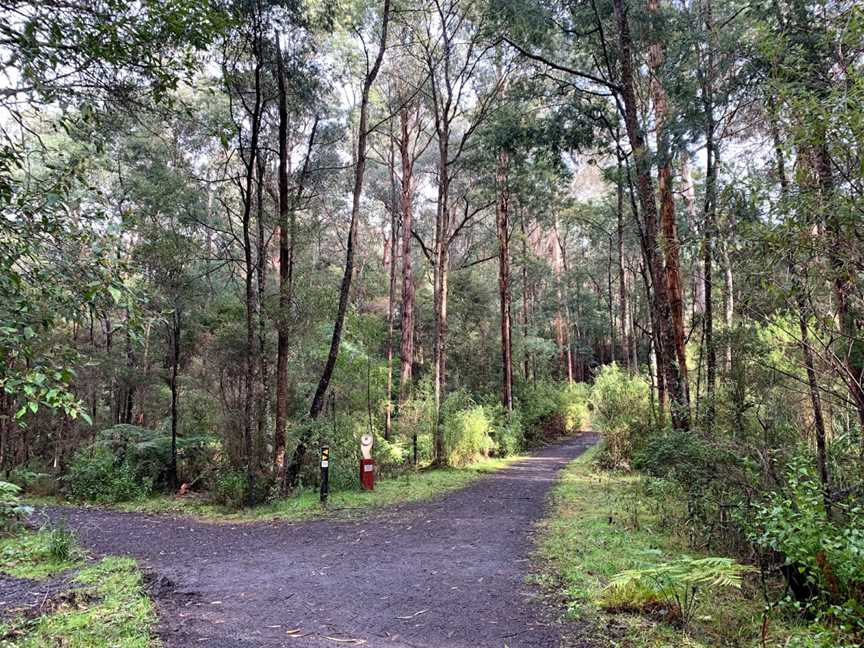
(66, 446), (151, 504)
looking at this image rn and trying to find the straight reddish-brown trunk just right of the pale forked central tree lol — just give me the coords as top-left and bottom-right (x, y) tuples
(495, 151), (513, 412)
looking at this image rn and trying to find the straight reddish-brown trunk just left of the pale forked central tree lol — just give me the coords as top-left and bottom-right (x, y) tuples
(399, 106), (417, 408)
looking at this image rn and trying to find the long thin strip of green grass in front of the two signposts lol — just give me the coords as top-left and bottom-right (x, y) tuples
(27, 455), (525, 523)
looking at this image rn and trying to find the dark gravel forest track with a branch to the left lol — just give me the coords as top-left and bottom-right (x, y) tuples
(37, 434), (597, 648)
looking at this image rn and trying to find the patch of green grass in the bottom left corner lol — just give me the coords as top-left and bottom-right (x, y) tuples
(0, 557), (158, 648)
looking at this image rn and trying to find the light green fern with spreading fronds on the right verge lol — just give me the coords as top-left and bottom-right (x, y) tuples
(601, 556), (753, 627)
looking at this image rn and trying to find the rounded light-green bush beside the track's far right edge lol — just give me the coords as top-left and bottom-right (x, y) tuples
(591, 364), (651, 468)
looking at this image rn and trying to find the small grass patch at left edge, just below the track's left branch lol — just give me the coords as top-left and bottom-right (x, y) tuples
(0, 529), (81, 579)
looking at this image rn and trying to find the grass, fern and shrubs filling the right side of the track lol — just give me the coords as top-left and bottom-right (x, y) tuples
(538, 367), (864, 648)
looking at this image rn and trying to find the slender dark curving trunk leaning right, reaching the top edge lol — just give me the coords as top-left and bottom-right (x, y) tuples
(286, 0), (390, 488)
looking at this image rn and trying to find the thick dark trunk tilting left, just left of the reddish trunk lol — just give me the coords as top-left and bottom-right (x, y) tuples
(613, 0), (690, 430)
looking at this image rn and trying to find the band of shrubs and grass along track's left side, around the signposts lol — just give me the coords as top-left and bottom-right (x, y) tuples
(12, 381), (588, 519)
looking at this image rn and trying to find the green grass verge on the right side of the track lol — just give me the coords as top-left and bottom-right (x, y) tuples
(536, 448), (837, 648)
